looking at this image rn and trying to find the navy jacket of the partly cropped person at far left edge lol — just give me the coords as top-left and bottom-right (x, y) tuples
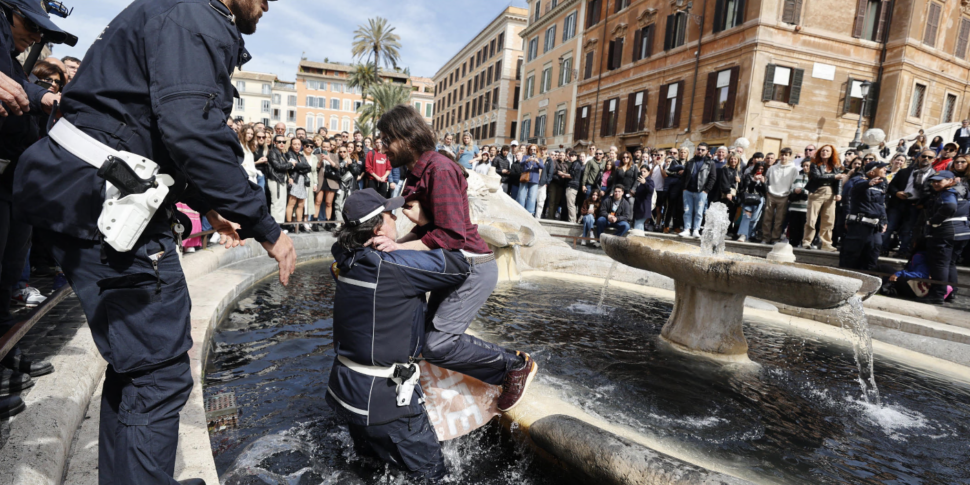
(0, 14), (47, 201)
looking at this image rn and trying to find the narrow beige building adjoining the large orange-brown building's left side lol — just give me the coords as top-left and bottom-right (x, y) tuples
(517, 0), (586, 148)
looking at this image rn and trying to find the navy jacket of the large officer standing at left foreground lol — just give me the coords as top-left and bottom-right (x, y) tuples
(14, 0), (280, 242)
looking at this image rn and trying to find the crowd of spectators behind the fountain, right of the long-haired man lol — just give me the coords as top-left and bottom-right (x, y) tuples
(438, 127), (970, 302)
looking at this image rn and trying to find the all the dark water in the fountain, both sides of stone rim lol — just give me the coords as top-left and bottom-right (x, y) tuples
(205, 264), (970, 484)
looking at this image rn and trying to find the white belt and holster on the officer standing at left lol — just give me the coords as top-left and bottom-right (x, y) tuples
(48, 118), (175, 252)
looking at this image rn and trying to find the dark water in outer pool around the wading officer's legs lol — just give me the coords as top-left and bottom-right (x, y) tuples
(204, 264), (575, 485)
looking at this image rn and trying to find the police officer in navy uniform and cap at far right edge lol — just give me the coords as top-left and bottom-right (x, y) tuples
(925, 170), (970, 305)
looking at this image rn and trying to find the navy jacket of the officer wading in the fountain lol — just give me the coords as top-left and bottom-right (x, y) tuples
(327, 243), (469, 426)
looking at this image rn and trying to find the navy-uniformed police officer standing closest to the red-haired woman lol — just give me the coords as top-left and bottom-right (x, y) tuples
(839, 161), (889, 271)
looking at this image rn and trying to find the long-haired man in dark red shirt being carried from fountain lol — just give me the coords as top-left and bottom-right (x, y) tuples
(371, 105), (538, 412)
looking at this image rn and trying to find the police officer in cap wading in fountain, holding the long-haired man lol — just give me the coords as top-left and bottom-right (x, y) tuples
(327, 189), (469, 481)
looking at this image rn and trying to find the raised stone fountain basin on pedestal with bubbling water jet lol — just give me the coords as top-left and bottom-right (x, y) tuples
(600, 229), (881, 361)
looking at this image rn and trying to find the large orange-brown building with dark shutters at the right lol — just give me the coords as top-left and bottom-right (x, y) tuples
(574, 0), (970, 152)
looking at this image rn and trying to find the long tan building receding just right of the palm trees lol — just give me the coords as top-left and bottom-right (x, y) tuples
(432, 7), (528, 145)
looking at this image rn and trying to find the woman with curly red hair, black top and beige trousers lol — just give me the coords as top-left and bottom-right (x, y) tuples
(801, 145), (845, 252)
